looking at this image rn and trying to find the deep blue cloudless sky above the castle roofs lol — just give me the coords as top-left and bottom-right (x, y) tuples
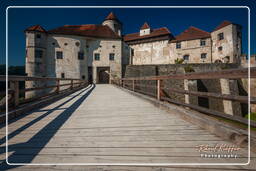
(0, 0), (256, 65)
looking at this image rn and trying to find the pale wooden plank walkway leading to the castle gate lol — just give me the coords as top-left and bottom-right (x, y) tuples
(0, 85), (256, 170)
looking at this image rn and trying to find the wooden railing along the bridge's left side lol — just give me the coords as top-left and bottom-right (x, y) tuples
(0, 75), (88, 109)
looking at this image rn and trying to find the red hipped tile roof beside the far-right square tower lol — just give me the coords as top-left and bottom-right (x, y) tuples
(172, 26), (211, 42)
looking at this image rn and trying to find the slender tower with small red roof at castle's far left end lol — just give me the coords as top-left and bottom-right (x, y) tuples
(25, 25), (47, 98)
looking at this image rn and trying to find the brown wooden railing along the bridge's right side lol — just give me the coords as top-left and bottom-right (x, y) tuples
(112, 67), (256, 127)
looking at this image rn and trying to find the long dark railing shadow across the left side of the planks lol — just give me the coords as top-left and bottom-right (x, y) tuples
(0, 85), (95, 170)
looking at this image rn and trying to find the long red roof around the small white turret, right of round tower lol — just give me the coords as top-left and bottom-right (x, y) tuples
(124, 27), (171, 42)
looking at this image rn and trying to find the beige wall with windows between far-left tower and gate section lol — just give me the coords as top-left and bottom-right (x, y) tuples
(46, 35), (88, 79)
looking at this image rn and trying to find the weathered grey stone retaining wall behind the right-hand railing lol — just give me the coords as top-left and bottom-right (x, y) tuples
(125, 64), (247, 116)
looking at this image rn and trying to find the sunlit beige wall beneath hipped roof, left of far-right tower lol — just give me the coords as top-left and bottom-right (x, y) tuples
(169, 38), (212, 64)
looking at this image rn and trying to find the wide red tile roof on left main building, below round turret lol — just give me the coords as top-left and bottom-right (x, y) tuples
(48, 24), (121, 39)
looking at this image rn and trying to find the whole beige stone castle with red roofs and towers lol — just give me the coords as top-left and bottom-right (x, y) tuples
(25, 12), (242, 91)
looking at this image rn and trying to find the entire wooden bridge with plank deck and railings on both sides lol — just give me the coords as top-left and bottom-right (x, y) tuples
(0, 69), (256, 171)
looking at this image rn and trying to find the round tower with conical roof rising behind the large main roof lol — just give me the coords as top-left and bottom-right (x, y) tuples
(102, 12), (122, 36)
